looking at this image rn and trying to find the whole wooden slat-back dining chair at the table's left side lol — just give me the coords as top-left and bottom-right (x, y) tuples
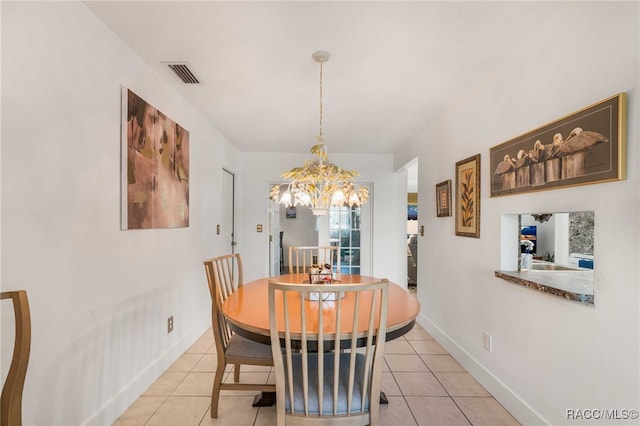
(204, 253), (275, 418)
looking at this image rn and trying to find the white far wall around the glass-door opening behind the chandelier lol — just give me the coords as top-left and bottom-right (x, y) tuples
(238, 151), (407, 286)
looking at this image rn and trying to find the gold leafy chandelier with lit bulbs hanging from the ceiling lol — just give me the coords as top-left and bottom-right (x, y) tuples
(270, 51), (369, 216)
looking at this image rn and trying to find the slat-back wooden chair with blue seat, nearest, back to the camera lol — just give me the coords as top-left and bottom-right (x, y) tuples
(269, 279), (389, 426)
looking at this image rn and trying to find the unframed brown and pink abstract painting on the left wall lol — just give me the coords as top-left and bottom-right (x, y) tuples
(120, 87), (189, 230)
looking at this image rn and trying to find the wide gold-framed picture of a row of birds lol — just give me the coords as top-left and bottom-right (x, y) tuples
(489, 93), (627, 197)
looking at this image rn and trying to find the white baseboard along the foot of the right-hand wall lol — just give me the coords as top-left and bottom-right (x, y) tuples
(416, 314), (550, 425)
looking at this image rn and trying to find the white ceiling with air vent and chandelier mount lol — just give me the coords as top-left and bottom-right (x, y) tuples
(86, 1), (559, 153)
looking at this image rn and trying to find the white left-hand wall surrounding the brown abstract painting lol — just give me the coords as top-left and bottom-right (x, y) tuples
(1, 2), (238, 425)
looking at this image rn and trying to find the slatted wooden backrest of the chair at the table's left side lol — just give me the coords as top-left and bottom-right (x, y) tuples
(204, 253), (243, 354)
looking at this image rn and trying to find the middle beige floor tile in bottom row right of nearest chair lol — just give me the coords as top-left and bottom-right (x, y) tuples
(406, 396), (470, 426)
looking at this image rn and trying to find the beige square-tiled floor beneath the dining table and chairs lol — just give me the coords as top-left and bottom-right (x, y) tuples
(114, 324), (519, 426)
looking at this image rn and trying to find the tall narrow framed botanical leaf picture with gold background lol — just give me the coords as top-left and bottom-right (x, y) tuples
(455, 154), (480, 238)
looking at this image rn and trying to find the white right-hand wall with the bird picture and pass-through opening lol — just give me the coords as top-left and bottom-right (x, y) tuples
(402, 2), (640, 425)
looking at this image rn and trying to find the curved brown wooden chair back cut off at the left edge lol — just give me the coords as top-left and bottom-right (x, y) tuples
(0, 290), (31, 426)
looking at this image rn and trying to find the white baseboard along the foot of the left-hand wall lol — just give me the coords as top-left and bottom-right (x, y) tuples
(82, 315), (211, 426)
